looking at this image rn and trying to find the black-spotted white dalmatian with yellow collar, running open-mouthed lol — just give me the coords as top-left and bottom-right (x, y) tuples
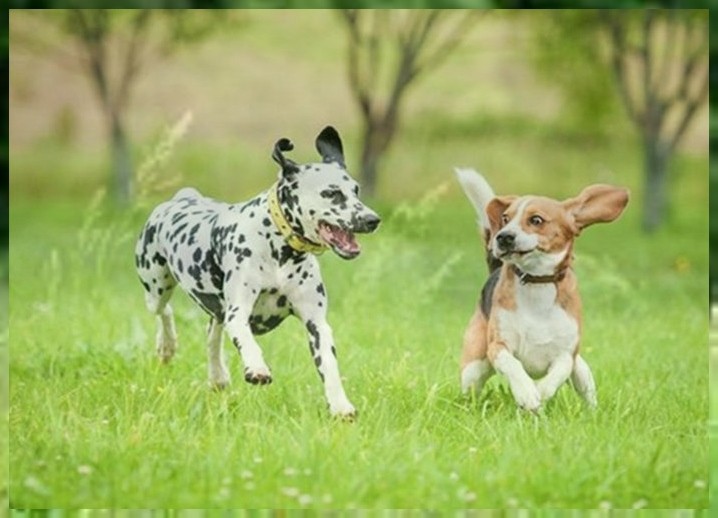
(135, 126), (380, 417)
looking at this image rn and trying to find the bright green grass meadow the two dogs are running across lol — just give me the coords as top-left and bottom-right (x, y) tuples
(10, 150), (709, 508)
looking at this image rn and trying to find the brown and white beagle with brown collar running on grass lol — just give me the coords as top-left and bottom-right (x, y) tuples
(456, 169), (628, 411)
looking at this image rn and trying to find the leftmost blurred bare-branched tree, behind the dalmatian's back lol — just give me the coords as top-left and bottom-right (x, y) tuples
(21, 9), (231, 205)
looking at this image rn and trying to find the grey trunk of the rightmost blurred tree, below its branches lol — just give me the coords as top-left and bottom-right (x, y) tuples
(643, 136), (670, 236)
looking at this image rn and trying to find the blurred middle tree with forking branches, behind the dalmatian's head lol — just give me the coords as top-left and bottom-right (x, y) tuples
(340, 9), (478, 195)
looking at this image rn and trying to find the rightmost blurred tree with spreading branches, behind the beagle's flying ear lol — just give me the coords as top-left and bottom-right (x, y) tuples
(601, 9), (708, 232)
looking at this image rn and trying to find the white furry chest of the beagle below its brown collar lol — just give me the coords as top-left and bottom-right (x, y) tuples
(497, 284), (579, 376)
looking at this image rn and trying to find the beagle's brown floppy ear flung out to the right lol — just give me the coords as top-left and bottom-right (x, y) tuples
(563, 184), (628, 232)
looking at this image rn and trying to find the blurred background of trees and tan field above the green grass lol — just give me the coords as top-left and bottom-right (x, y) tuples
(10, 10), (708, 203)
